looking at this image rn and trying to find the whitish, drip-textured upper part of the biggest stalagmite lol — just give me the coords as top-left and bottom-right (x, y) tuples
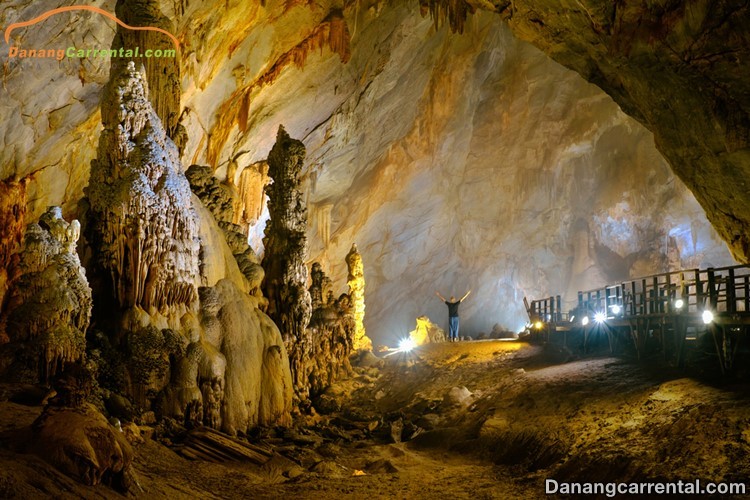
(86, 62), (199, 314)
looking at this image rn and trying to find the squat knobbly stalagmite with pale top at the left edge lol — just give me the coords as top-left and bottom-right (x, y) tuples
(0, 207), (92, 384)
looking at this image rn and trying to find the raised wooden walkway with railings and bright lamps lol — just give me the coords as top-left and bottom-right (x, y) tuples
(524, 265), (750, 372)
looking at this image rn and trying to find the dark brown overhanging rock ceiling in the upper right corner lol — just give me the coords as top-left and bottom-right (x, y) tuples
(431, 0), (750, 262)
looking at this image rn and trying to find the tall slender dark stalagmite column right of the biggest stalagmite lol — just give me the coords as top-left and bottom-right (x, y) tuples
(262, 127), (311, 399)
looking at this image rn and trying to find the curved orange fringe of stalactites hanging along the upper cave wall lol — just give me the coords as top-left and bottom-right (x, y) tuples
(206, 9), (351, 168)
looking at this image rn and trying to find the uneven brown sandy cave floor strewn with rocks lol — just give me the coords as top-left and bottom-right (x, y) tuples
(0, 340), (750, 499)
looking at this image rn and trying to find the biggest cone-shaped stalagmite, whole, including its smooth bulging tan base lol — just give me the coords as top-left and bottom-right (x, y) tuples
(87, 63), (292, 433)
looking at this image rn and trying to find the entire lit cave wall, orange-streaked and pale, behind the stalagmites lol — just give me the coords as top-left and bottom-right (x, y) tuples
(0, 0), (731, 344)
